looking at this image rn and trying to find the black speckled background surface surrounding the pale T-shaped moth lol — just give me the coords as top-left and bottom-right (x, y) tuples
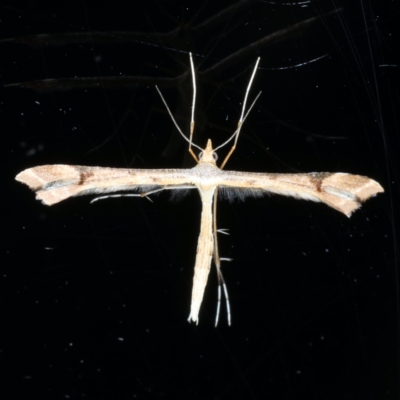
(0, 0), (400, 399)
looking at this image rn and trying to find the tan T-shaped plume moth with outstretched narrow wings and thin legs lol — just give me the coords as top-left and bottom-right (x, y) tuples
(16, 54), (383, 324)
